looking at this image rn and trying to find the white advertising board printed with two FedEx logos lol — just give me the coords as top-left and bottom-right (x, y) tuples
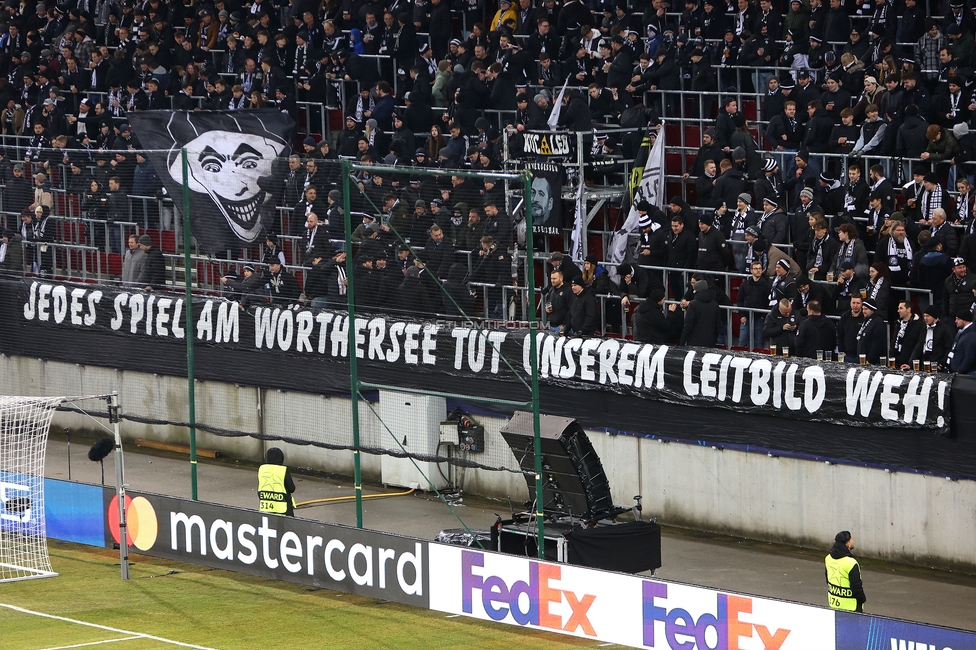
(429, 544), (835, 650)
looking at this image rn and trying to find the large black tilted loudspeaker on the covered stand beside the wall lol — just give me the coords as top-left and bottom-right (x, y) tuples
(501, 411), (616, 521)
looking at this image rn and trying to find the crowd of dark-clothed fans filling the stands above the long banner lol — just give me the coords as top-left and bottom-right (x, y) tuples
(0, 0), (976, 372)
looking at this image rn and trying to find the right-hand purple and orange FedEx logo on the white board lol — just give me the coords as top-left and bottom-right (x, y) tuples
(643, 581), (790, 650)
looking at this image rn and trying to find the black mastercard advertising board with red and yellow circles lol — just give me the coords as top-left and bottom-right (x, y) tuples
(104, 492), (428, 607)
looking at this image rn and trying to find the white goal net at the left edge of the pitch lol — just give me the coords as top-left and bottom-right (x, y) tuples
(0, 396), (65, 582)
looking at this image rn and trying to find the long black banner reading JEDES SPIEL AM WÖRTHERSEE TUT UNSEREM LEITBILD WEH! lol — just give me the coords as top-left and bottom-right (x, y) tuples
(0, 280), (950, 432)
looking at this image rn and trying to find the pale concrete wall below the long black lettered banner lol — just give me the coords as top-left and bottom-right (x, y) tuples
(7, 356), (976, 571)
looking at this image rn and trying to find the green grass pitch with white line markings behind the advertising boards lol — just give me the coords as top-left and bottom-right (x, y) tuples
(0, 542), (598, 650)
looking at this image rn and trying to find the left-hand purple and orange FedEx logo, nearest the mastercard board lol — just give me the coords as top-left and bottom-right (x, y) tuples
(461, 551), (596, 637)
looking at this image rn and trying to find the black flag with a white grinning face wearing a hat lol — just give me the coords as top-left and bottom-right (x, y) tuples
(127, 109), (295, 253)
